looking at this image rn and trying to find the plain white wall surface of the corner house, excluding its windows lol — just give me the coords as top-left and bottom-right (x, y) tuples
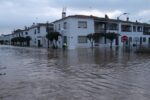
(55, 17), (94, 49)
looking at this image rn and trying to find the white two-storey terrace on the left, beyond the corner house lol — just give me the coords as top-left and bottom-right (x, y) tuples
(12, 23), (53, 47)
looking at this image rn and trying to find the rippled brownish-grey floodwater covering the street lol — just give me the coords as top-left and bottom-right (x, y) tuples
(0, 45), (150, 100)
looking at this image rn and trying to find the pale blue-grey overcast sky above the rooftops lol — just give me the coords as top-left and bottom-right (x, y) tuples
(0, 0), (150, 34)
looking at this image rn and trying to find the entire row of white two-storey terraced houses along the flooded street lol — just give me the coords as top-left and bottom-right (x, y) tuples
(0, 13), (150, 49)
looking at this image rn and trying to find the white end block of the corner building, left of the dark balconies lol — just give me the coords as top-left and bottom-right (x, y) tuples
(54, 16), (94, 49)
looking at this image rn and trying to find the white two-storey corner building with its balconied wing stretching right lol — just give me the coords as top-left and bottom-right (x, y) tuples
(53, 15), (150, 49)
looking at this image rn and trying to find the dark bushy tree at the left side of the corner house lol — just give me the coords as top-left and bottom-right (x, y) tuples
(46, 32), (61, 48)
